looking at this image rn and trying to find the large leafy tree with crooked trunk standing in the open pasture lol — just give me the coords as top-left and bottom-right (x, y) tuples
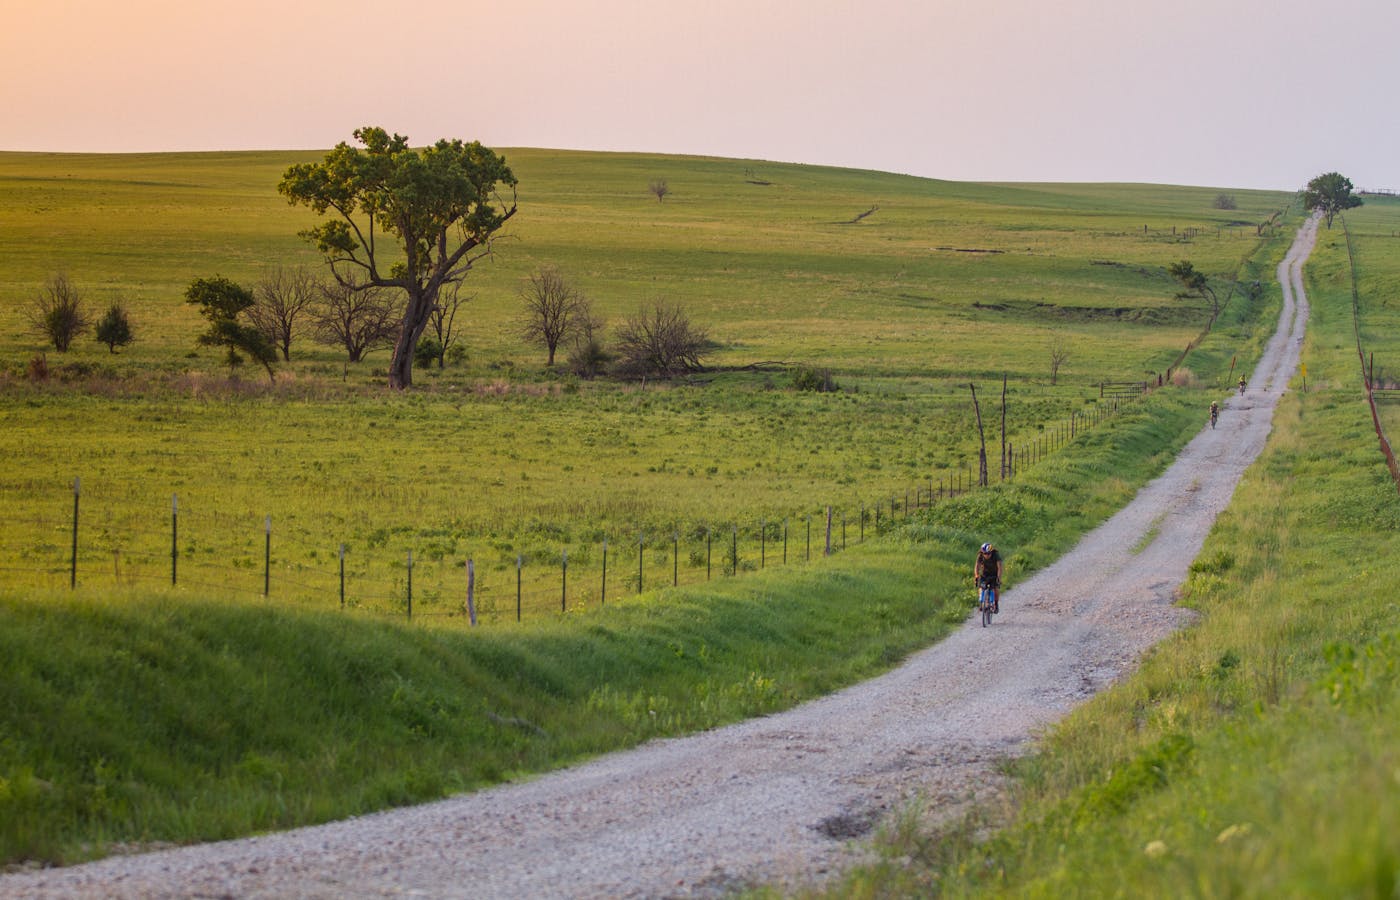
(277, 126), (515, 389)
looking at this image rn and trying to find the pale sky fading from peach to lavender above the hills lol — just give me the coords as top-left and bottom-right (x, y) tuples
(0, 0), (1400, 190)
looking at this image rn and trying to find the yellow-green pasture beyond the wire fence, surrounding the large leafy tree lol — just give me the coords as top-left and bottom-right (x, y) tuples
(0, 150), (1288, 617)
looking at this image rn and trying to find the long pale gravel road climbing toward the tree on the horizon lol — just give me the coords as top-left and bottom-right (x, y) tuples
(0, 220), (1316, 899)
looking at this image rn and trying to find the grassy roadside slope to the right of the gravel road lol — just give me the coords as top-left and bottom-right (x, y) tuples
(833, 203), (1400, 897)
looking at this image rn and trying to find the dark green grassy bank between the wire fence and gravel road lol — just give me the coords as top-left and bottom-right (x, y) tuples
(0, 377), (1198, 862)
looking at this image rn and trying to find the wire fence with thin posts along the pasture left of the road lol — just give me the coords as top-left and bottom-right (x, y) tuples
(0, 394), (1151, 624)
